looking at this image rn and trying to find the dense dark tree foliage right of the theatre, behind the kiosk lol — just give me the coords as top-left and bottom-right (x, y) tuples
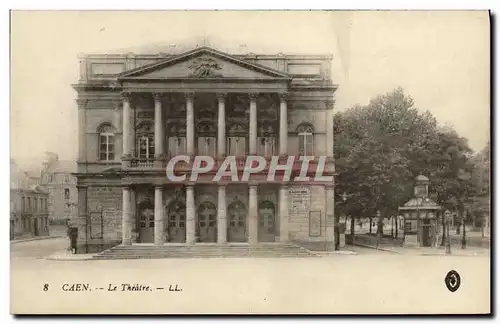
(334, 88), (477, 217)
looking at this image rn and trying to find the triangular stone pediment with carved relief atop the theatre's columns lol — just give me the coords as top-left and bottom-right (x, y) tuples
(118, 47), (290, 80)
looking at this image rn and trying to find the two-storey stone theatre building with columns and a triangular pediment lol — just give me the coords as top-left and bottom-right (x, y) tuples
(73, 41), (337, 252)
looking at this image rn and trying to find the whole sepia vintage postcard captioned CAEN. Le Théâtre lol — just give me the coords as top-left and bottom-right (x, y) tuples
(10, 11), (492, 315)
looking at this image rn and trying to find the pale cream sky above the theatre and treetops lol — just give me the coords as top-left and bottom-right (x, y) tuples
(10, 11), (490, 166)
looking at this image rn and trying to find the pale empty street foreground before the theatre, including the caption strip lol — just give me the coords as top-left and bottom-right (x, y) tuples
(11, 239), (490, 314)
